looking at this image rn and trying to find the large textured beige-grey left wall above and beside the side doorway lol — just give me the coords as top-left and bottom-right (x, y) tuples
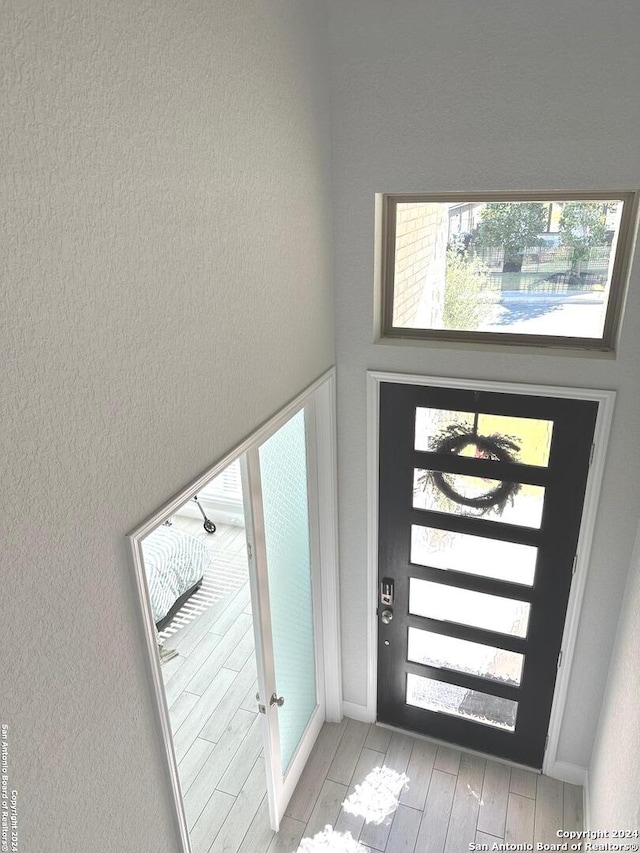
(0, 0), (334, 853)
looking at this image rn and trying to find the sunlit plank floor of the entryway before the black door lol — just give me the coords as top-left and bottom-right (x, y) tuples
(278, 720), (582, 853)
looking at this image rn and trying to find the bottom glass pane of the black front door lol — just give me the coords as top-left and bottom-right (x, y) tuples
(406, 673), (518, 732)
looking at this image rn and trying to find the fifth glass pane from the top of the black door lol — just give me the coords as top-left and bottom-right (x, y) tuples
(408, 628), (524, 685)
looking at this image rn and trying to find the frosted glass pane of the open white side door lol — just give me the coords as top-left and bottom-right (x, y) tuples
(259, 411), (317, 773)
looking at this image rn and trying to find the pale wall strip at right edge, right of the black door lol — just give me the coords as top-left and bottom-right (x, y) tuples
(588, 529), (640, 830)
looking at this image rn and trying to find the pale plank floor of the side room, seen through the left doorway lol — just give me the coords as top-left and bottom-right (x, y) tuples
(162, 516), (266, 853)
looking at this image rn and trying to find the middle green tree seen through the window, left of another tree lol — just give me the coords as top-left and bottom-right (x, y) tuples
(478, 201), (547, 272)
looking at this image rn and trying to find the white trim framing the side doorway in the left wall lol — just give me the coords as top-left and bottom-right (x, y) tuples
(127, 367), (342, 853)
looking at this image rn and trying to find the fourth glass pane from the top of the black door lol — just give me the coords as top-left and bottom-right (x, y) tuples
(409, 578), (531, 637)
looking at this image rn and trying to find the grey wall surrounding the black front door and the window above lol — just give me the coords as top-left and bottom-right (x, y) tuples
(329, 0), (640, 767)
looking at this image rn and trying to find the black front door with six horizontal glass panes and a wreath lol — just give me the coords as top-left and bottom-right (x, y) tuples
(378, 382), (598, 768)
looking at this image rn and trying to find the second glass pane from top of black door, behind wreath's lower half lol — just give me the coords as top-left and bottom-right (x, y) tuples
(413, 468), (545, 529)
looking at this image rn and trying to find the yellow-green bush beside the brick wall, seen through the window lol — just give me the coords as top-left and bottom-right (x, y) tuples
(442, 248), (494, 329)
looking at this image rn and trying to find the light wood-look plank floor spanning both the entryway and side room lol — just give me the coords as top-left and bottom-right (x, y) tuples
(158, 530), (582, 853)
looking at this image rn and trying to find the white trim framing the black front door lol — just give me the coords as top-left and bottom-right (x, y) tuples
(366, 371), (616, 776)
